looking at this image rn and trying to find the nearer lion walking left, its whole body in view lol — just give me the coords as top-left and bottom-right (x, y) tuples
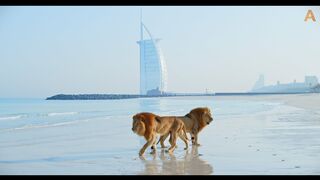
(132, 112), (188, 156)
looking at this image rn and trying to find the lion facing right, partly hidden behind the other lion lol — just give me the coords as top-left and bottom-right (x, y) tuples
(157, 107), (213, 148)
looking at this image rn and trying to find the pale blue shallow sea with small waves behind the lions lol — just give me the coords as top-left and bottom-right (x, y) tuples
(0, 97), (275, 133)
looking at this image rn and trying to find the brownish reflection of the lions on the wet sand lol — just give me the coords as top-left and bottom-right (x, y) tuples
(139, 147), (213, 175)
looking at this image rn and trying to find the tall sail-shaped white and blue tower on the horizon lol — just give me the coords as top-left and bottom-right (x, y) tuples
(137, 14), (167, 95)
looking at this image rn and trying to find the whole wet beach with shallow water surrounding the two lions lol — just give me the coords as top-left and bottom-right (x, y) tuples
(0, 94), (320, 175)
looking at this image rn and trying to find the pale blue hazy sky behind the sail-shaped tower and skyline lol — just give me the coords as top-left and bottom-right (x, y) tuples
(0, 6), (320, 98)
